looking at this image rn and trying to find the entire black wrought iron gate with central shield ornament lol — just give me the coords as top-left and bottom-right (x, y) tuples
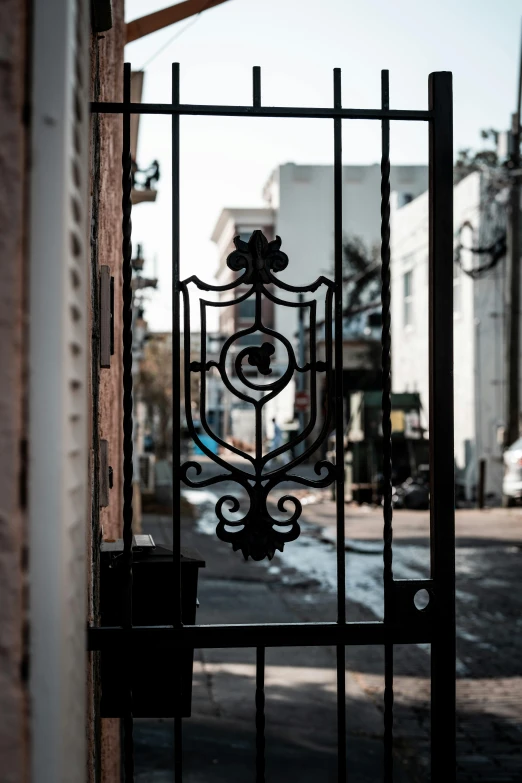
(89, 64), (450, 783)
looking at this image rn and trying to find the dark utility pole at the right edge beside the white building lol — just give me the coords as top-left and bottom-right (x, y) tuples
(504, 21), (522, 448)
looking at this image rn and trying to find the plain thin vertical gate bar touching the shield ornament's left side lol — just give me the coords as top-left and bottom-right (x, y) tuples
(172, 63), (183, 783)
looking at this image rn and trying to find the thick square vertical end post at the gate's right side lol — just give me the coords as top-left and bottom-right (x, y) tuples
(429, 72), (456, 783)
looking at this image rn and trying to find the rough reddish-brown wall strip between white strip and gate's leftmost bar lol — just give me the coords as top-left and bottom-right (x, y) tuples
(88, 0), (124, 783)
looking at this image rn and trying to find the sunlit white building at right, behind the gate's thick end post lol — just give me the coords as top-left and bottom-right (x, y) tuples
(391, 173), (505, 498)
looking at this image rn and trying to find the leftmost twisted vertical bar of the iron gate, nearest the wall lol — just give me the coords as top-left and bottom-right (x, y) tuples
(122, 63), (134, 781)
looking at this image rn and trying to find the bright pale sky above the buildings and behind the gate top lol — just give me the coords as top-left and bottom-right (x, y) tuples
(125, 0), (522, 331)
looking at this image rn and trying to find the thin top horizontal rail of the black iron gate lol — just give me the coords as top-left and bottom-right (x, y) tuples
(91, 101), (433, 122)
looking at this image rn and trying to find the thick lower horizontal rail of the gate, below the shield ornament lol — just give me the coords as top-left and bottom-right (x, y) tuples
(88, 622), (432, 650)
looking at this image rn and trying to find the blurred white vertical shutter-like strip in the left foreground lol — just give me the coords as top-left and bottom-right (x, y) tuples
(29, 0), (90, 783)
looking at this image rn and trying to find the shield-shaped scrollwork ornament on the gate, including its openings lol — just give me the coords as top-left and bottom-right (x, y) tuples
(180, 231), (334, 560)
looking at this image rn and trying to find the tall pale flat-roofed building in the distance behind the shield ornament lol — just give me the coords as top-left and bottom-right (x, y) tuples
(212, 163), (428, 432)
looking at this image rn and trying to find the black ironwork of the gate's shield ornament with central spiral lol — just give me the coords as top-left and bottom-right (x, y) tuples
(180, 231), (336, 560)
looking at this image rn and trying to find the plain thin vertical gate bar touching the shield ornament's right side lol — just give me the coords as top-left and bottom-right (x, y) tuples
(333, 68), (346, 783)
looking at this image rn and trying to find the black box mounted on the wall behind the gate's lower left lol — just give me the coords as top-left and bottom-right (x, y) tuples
(100, 539), (205, 718)
